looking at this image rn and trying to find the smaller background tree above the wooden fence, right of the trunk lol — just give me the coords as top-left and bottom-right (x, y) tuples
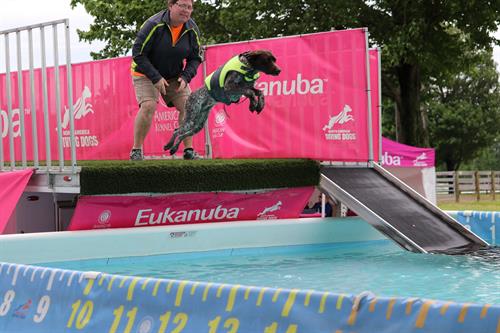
(424, 52), (500, 171)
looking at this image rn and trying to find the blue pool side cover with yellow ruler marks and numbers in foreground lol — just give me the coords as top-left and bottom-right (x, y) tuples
(0, 263), (500, 333)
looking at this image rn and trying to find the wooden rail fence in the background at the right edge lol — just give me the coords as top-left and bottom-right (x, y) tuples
(436, 171), (500, 202)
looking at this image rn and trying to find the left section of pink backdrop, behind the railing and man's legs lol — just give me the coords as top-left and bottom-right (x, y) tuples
(0, 57), (205, 161)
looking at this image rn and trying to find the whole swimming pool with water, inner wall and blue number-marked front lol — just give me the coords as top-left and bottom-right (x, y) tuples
(0, 215), (500, 333)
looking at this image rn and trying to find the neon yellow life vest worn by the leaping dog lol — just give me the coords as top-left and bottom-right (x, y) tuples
(205, 55), (260, 105)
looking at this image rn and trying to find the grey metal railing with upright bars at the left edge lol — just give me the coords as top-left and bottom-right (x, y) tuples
(0, 19), (76, 173)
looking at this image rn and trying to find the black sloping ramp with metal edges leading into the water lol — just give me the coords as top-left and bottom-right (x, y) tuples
(320, 164), (488, 254)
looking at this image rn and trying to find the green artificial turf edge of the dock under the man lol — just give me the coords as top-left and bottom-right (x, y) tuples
(78, 159), (319, 195)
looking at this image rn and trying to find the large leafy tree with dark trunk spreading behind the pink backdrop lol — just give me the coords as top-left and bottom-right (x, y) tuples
(71, 0), (500, 146)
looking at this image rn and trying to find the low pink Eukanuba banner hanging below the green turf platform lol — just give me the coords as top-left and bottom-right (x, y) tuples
(68, 187), (314, 230)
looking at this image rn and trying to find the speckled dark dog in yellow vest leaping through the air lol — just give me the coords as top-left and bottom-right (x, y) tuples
(163, 50), (281, 155)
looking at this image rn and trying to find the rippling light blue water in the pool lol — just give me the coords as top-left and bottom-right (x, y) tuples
(46, 241), (500, 304)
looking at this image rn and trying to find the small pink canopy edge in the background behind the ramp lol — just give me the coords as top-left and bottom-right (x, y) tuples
(382, 137), (435, 168)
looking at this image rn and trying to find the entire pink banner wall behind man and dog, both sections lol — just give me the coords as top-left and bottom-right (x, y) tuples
(0, 29), (379, 161)
